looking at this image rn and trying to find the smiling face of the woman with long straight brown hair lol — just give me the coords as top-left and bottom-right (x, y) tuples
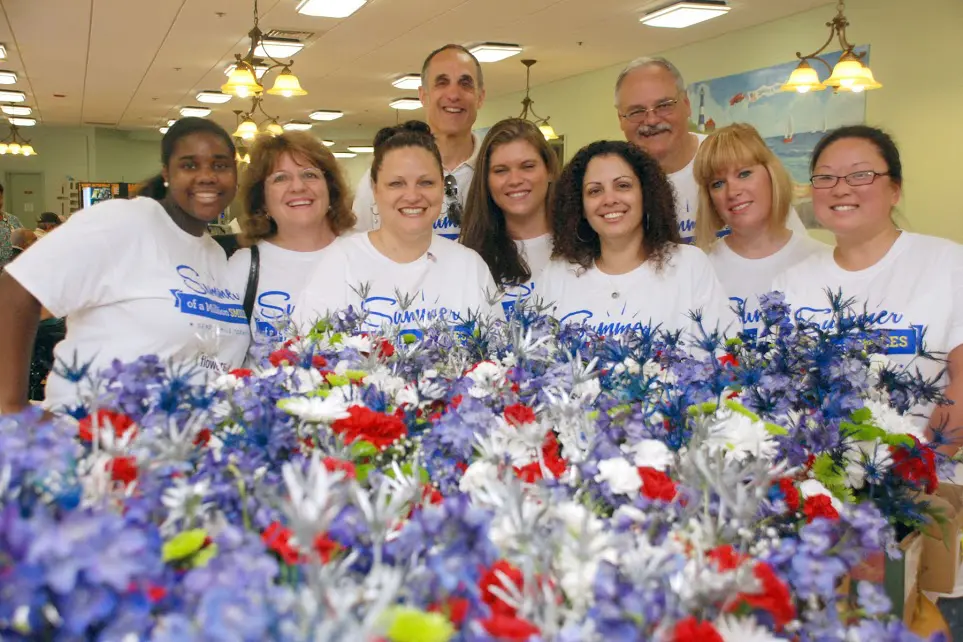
(488, 140), (548, 231)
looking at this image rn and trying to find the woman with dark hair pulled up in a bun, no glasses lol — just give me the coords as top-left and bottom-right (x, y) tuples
(295, 123), (501, 333)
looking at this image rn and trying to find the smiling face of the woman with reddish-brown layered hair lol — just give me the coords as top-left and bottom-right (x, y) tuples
(264, 152), (330, 233)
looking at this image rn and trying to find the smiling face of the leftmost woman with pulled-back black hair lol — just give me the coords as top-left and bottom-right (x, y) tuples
(162, 132), (237, 223)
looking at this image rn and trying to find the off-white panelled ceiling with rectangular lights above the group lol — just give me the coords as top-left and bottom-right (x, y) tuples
(0, 0), (827, 141)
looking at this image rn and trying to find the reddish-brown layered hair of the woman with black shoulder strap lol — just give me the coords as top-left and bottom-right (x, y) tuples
(238, 131), (358, 247)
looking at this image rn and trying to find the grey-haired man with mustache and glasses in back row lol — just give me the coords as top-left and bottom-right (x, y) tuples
(615, 57), (807, 243)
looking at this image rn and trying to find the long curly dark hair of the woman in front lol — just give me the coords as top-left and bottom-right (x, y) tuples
(552, 140), (681, 270)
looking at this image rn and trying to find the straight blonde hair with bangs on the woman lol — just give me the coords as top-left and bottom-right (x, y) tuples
(692, 123), (792, 250)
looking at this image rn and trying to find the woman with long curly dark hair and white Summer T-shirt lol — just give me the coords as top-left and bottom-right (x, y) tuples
(541, 141), (733, 335)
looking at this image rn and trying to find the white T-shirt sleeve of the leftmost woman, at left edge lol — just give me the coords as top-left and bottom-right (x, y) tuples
(4, 200), (136, 317)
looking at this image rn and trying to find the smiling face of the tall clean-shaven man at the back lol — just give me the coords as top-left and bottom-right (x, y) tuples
(418, 49), (485, 136)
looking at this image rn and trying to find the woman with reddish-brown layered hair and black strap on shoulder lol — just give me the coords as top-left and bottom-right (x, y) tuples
(230, 132), (355, 340)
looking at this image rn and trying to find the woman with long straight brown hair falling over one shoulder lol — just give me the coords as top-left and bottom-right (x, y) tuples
(459, 118), (558, 312)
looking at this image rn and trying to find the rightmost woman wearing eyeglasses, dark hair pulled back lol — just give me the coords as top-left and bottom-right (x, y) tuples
(773, 125), (963, 450)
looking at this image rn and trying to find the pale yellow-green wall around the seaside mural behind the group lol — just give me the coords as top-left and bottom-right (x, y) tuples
(478, 0), (963, 242)
